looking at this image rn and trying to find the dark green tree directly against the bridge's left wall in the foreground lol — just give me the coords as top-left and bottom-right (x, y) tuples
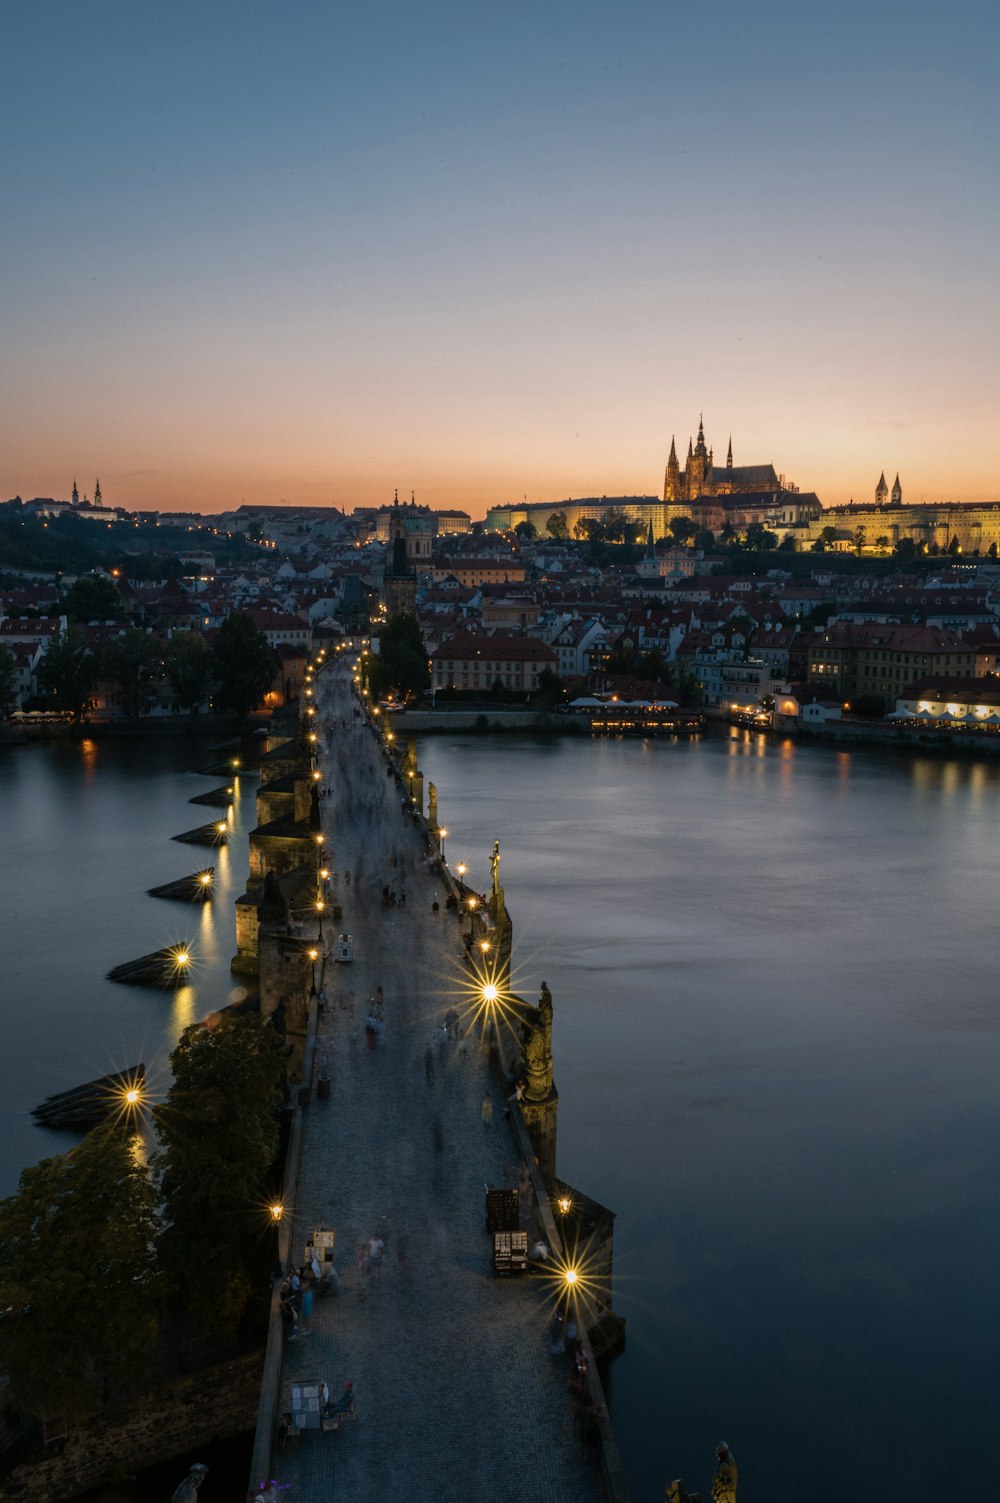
(153, 1013), (284, 1341)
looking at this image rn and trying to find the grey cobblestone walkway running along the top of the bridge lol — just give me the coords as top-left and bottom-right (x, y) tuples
(272, 666), (603, 1503)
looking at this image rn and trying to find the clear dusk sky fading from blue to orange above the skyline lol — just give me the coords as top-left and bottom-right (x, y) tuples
(0, 0), (1000, 516)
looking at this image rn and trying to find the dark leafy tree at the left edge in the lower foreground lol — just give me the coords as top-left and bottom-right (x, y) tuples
(0, 1126), (156, 1420)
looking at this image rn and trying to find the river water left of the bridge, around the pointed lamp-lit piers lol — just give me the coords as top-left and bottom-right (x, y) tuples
(0, 739), (257, 1195)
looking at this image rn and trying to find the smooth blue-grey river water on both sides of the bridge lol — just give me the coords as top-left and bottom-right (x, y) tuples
(0, 733), (1000, 1503)
